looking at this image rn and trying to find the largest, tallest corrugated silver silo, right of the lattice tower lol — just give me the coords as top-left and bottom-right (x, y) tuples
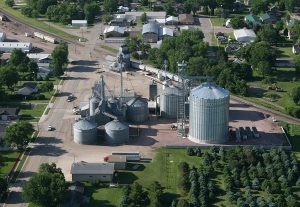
(189, 82), (229, 143)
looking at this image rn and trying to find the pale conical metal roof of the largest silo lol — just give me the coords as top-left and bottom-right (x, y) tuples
(190, 82), (229, 99)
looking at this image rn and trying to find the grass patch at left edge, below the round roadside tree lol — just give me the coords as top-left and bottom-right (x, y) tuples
(0, 151), (20, 177)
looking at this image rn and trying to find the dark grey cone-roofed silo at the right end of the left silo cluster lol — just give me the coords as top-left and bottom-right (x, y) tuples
(126, 97), (149, 124)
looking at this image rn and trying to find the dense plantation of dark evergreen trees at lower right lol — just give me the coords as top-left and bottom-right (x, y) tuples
(187, 147), (300, 207)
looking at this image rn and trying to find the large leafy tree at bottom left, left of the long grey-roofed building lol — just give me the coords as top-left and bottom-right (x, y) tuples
(22, 163), (66, 207)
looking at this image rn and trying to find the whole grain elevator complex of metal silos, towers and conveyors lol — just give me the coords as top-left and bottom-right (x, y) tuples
(73, 46), (234, 145)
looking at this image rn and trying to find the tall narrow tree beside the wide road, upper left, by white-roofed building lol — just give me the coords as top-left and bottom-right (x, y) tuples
(51, 43), (69, 76)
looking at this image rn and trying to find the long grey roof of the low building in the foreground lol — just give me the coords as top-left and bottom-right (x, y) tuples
(71, 162), (114, 175)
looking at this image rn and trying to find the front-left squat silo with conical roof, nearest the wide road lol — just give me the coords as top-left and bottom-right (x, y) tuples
(73, 119), (97, 144)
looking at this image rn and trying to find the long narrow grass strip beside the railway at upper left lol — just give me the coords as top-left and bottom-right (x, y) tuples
(0, 0), (78, 40)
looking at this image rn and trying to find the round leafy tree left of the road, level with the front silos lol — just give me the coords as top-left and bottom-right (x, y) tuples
(4, 121), (34, 149)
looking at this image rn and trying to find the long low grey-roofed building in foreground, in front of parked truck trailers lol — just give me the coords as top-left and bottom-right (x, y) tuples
(71, 162), (114, 182)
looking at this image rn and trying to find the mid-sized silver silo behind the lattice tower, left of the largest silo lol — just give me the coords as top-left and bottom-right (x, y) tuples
(159, 87), (179, 118)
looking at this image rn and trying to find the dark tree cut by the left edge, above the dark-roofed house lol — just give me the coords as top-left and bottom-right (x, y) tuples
(0, 65), (19, 90)
